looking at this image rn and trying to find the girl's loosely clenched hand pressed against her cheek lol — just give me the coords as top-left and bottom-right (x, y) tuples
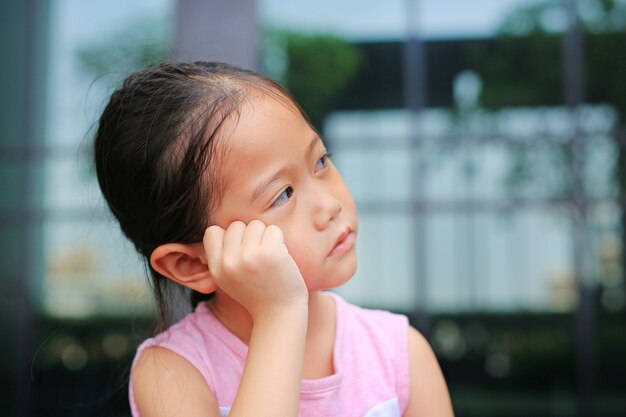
(203, 220), (308, 319)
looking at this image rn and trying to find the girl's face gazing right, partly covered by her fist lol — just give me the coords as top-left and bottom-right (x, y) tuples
(213, 96), (358, 291)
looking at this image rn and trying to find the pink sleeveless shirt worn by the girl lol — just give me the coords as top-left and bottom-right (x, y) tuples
(130, 293), (409, 417)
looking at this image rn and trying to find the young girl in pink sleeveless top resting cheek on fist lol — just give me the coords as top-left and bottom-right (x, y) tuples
(95, 62), (452, 417)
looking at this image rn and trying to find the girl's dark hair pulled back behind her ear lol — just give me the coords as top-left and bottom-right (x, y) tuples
(94, 62), (308, 331)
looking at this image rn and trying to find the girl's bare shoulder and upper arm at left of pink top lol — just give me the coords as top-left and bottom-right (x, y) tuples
(131, 346), (219, 417)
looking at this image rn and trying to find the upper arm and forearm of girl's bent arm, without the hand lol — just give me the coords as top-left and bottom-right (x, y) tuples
(131, 309), (307, 417)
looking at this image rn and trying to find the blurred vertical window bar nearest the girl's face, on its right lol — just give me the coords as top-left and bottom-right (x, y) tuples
(404, 0), (430, 336)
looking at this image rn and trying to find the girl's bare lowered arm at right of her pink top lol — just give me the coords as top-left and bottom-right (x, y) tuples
(404, 327), (454, 417)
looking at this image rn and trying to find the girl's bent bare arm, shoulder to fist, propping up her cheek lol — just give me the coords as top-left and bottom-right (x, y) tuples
(132, 221), (308, 417)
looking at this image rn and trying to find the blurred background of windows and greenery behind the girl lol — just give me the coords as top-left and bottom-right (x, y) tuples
(0, 0), (626, 417)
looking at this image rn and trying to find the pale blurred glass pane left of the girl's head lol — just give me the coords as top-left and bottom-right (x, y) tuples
(41, 0), (175, 318)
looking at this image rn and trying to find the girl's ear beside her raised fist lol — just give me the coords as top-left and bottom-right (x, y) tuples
(150, 243), (217, 294)
